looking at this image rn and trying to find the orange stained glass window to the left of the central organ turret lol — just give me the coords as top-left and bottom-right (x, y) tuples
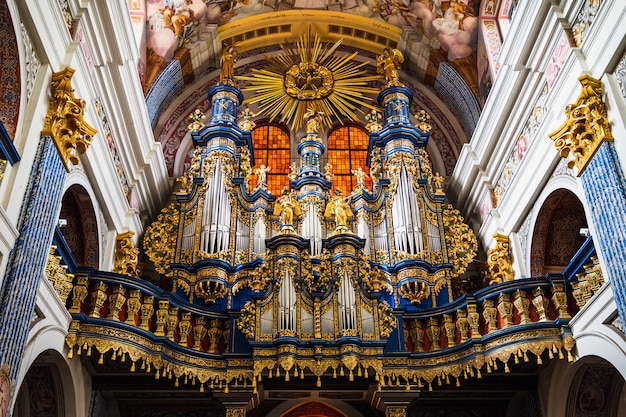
(250, 125), (291, 195)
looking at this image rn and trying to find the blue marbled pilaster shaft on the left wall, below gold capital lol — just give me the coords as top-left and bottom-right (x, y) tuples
(0, 136), (66, 382)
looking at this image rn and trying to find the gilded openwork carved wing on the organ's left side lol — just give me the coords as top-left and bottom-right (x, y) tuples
(143, 203), (180, 276)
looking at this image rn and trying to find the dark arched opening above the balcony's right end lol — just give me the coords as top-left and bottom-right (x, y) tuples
(530, 188), (587, 276)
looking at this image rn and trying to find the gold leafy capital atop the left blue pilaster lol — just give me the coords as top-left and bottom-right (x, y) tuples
(41, 67), (97, 172)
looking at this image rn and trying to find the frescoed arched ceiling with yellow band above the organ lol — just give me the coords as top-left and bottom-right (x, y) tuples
(139, 0), (480, 180)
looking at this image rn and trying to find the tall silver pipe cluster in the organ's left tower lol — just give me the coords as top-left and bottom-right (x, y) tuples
(200, 161), (231, 253)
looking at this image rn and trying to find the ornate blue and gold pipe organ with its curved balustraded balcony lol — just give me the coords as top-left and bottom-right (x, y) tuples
(59, 48), (580, 395)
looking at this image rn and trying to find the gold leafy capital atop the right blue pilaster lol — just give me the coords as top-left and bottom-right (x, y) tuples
(548, 74), (613, 176)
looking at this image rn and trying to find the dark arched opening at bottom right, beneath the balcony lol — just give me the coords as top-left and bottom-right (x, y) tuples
(566, 356), (626, 417)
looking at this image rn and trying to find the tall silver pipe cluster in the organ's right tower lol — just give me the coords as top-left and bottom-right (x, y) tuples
(391, 166), (424, 254)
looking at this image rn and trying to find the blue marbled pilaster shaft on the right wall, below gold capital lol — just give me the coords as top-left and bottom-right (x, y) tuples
(580, 142), (626, 323)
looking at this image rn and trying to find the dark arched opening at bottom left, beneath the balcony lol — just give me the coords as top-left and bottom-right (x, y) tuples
(13, 349), (76, 417)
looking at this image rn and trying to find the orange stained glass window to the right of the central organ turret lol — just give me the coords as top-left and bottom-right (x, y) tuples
(328, 126), (372, 195)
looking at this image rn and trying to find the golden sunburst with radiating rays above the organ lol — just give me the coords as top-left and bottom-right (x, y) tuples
(236, 25), (380, 130)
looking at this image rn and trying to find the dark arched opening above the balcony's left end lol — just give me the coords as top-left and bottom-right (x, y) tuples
(59, 184), (100, 268)
